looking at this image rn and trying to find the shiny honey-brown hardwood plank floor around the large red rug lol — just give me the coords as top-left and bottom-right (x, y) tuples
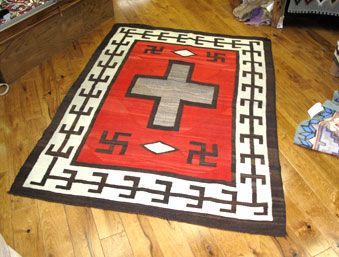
(0, 0), (339, 257)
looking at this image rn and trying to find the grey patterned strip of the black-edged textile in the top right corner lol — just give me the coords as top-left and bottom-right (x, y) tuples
(288, 0), (339, 16)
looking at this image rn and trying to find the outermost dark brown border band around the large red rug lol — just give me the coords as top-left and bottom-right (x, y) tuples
(9, 23), (286, 236)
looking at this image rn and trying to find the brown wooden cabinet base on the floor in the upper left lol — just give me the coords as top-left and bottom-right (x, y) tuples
(0, 0), (113, 83)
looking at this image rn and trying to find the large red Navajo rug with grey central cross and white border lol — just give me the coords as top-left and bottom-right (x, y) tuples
(10, 24), (285, 235)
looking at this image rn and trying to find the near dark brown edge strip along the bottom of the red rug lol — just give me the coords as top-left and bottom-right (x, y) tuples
(9, 184), (287, 237)
